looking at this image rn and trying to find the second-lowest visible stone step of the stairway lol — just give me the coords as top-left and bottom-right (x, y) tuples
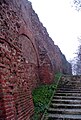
(48, 108), (81, 115)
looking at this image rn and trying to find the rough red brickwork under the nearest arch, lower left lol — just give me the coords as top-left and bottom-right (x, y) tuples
(0, 39), (34, 120)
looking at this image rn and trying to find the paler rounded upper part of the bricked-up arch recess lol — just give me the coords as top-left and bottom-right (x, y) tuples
(18, 35), (37, 65)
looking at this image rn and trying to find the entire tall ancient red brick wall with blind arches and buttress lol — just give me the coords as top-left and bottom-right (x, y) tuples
(0, 0), (71, 120)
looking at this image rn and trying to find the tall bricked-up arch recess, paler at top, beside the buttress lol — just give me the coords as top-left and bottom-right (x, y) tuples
(18, 35), (39, 89)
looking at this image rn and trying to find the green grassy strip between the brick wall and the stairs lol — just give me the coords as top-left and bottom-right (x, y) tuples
(32, 73), (61, 120)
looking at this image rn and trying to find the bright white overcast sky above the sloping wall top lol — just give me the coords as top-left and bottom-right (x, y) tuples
(29, 0), (81, 60)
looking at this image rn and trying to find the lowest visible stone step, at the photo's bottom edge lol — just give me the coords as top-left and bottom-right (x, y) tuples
(48, 114), (81, 120)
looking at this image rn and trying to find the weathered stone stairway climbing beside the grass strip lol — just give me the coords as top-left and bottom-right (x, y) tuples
(45, 76), (81, 120)
